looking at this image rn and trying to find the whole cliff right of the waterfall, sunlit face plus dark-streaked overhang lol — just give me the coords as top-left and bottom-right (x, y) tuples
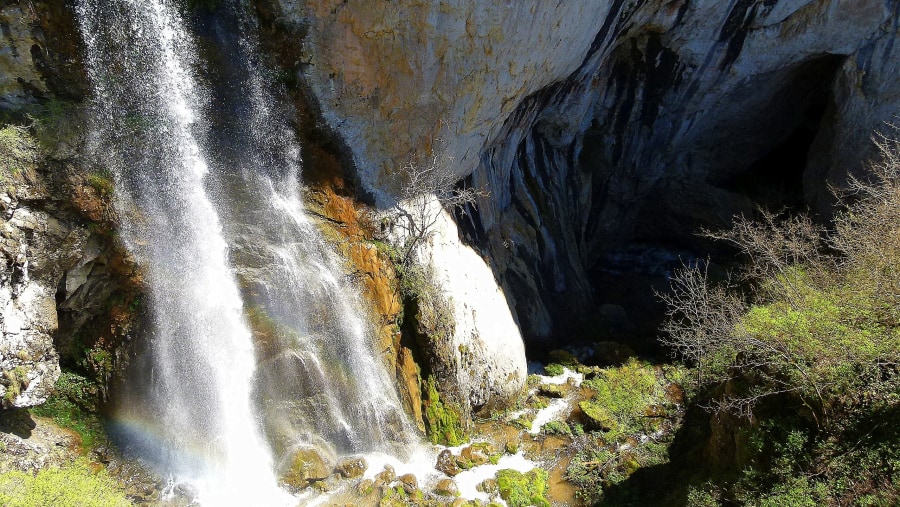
(262, 0), (900, 344)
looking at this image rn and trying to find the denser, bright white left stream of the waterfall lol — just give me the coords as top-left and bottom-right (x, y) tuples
(78, 0), (286, 505)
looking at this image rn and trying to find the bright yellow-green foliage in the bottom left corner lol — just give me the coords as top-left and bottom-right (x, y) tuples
(0, 460), (131, 507)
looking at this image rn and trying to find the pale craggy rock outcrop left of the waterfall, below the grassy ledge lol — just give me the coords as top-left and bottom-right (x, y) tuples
(0, 130), (139, 408)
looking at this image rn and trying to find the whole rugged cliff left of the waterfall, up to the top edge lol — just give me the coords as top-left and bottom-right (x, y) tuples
(0, 2), (140, 408)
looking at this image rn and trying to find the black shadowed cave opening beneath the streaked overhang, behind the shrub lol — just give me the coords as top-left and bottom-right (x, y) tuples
(577, 55), (844, 355)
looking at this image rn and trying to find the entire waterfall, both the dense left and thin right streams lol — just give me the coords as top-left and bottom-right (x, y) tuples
(77, 0), (415, 505)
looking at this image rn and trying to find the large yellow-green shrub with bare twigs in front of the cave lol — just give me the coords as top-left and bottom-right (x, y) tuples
(662, 132), (900, 506)
